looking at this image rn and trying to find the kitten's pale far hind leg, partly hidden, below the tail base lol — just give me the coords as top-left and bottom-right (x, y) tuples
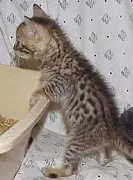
(96, 147), (112, 166)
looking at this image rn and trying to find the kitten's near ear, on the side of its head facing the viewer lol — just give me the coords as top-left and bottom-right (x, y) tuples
(24, 16), (35, 36)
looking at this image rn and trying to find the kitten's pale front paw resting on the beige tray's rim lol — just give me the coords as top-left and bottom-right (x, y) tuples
(29, 92), (43, 109)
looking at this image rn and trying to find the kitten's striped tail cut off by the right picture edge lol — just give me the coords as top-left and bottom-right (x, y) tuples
(113, 133), (133, 159)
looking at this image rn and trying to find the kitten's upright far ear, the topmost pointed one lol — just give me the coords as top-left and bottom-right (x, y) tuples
(33, 4), (49, 18)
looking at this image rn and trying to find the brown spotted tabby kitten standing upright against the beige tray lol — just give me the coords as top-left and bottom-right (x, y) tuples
(14, 4), (133, 178)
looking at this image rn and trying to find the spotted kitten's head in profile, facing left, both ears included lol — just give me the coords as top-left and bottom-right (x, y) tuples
(14, 4), (61, 69)
